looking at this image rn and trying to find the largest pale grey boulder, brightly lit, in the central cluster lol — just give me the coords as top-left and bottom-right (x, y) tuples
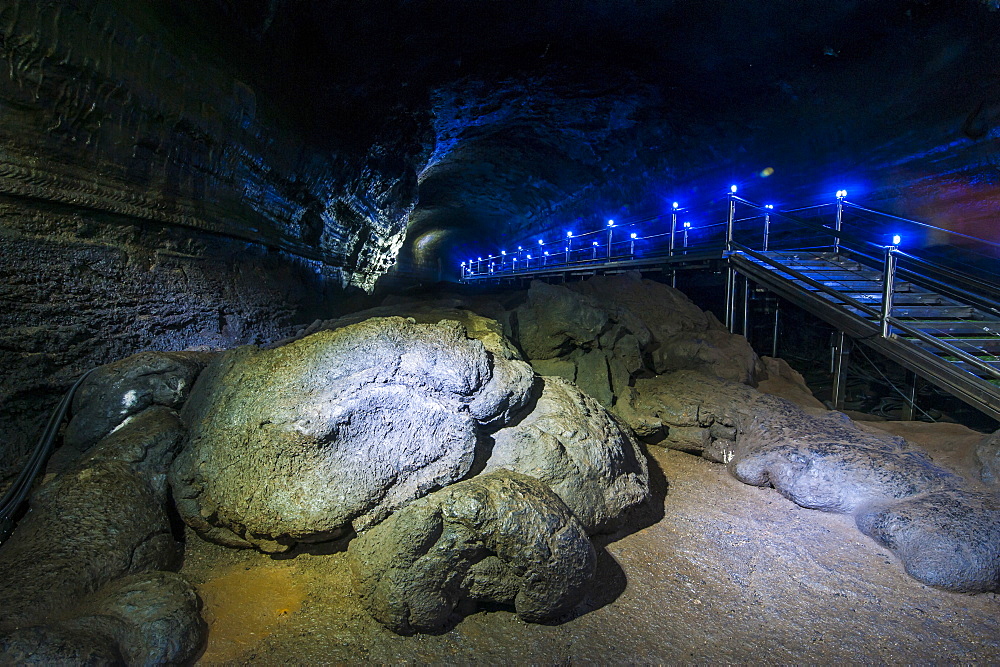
(170, 317), (534, 552)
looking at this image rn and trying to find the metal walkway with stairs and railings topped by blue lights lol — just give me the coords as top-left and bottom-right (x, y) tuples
(463, 192), (1000, 420)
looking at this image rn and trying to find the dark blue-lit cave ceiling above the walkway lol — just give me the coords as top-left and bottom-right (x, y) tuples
(7, 0), (1000, 284)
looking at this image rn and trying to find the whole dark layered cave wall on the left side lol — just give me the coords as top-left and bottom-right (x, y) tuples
(0, 0), (420, 470)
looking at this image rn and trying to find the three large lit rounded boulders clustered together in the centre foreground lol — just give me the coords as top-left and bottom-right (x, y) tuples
(170, 312), (649, 632)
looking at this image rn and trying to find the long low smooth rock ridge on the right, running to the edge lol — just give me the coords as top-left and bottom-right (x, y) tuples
(620, 371), (1000, 592)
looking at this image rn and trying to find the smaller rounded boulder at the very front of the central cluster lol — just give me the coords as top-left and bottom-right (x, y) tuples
(348, 470), (596, 634)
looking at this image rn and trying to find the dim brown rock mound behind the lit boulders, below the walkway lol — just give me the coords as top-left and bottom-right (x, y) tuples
(511, 273), (763, 409)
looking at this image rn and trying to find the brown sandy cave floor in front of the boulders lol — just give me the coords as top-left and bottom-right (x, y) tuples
(182, 423), (1000, 664)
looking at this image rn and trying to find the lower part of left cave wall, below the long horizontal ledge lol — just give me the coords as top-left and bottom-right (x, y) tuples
(0, 198), (364, 469)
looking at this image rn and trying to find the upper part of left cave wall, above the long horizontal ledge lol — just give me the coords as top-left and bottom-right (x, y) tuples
(0, 0), (415, 286)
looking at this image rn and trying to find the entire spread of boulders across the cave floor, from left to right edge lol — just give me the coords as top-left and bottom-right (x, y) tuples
(0, 275), (1000, 661)
